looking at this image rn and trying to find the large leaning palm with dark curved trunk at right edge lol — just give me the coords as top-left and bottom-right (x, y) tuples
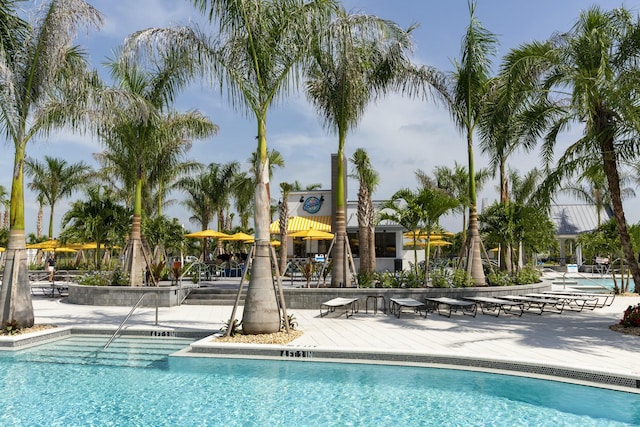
(503, 6), (640, 289)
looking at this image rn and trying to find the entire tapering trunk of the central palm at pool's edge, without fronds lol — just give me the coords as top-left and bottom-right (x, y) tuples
(242, 117), (280, 334)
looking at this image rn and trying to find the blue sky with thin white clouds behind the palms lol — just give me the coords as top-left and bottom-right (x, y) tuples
(5, 0), (640, 236)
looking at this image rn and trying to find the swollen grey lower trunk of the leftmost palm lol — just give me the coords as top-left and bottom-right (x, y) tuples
(0, 230), (34, 328)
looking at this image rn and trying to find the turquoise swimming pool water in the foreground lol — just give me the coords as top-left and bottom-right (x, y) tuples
(0, 340), (640, 426)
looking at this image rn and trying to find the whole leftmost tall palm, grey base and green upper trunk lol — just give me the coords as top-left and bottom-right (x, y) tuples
(0, 0), (102, 328)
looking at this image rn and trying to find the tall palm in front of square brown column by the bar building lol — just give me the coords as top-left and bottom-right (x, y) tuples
(306, 9), (424, 287)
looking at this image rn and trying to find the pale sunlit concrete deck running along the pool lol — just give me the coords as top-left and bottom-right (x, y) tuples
(27, 280), (640, 394)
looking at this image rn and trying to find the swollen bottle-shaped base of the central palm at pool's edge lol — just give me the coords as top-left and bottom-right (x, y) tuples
(242, 242), (280, 334)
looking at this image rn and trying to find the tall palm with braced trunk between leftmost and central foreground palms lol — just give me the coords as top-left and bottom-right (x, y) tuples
(100, 47), (218, 286)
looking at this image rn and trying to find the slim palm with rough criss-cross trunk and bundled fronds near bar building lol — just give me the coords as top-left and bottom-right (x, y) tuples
(351, 148), (380, 273)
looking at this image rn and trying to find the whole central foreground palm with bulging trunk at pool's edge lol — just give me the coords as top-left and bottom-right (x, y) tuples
(124, 0), (336, 334)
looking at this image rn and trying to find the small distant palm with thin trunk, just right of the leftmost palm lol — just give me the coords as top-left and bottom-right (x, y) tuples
(25, 156), (92, 239)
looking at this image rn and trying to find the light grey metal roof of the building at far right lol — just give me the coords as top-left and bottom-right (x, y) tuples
(549, 204), (611, 236)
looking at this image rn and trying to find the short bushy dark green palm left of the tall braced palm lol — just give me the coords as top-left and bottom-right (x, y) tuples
(60, 185), (131, 269)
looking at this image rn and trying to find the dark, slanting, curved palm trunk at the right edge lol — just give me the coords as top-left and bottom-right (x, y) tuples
(601, 138), (640, 292)
